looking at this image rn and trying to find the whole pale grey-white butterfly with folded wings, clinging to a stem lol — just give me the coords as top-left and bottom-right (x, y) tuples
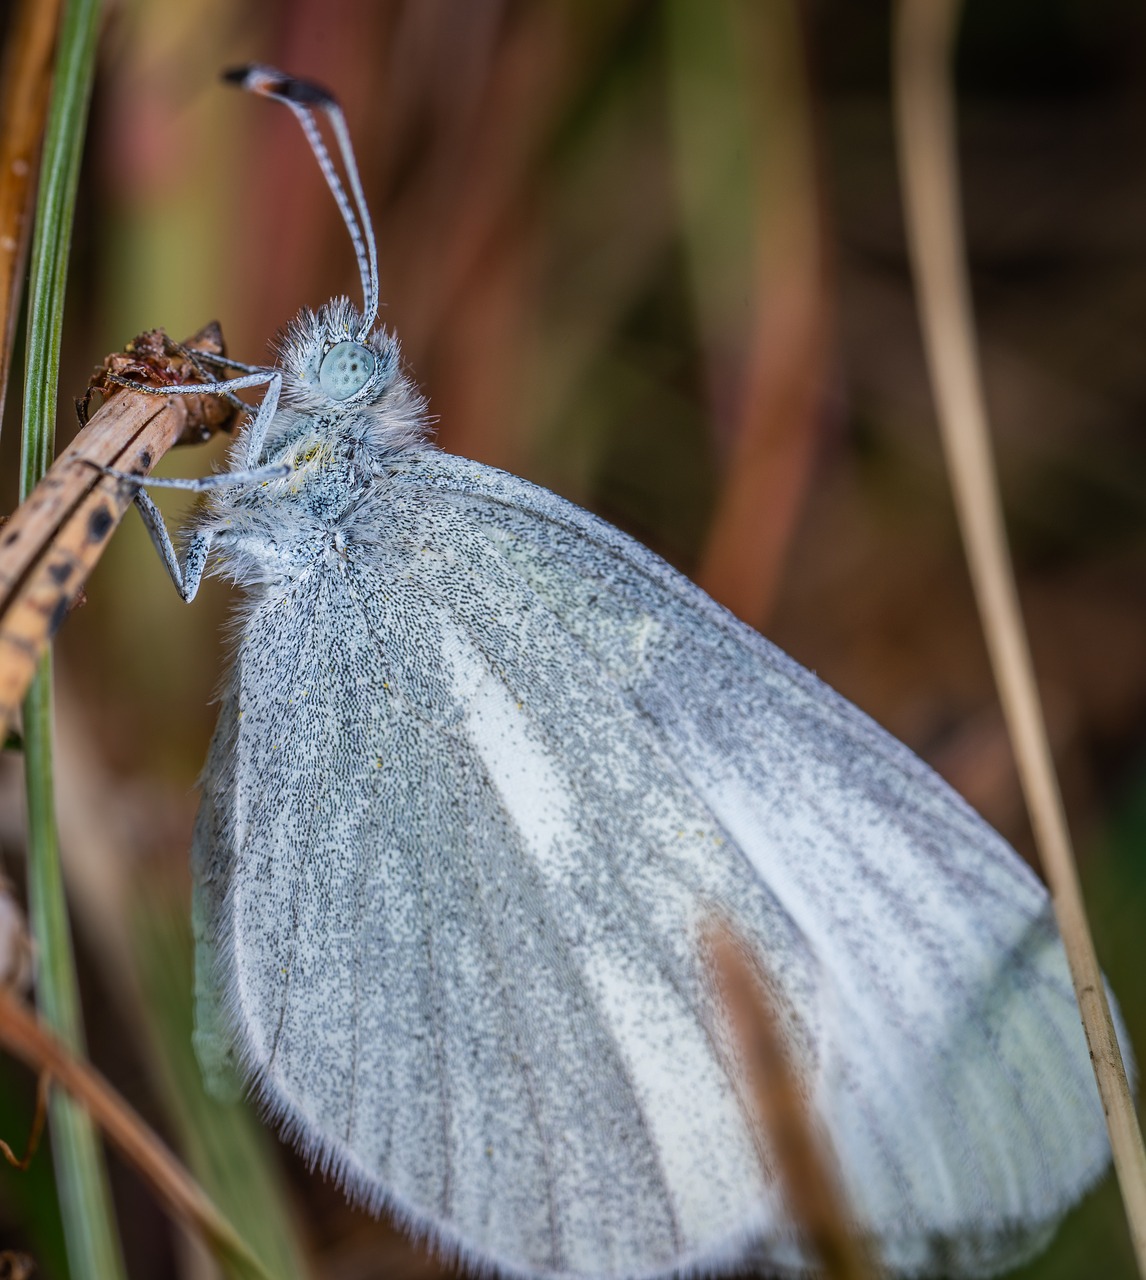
(113, 67), (1109, 1276)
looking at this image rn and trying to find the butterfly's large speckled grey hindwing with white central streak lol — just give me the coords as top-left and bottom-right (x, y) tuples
(196, 514), (813, 1275)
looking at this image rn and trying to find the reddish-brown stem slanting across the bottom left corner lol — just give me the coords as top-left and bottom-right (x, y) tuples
(0, 991), (268, 1280)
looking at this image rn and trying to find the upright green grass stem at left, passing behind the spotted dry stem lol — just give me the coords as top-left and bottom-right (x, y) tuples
(20, 0), (125, 1280)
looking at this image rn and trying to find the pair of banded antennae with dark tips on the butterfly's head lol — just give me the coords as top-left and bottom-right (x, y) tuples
(223, 63), (378, 342)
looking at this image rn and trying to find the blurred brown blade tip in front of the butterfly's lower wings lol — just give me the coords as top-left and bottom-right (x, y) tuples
(704, 922), (876, 1280)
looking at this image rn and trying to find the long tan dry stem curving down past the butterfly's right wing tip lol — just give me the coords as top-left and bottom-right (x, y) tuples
(895, 0), (1146, 1276)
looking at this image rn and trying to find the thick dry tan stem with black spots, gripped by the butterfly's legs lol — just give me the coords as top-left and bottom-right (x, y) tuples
(0, 325), (236, 739)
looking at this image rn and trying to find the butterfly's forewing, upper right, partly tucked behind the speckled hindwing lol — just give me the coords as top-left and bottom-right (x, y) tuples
(402, 458), (1109, 1270)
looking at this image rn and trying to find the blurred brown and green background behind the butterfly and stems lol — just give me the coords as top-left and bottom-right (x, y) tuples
(0, 0), (1146, 1280)
